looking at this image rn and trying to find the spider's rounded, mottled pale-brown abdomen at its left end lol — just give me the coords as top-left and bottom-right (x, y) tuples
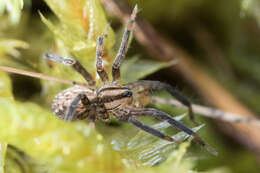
(51, 85), (95, 120)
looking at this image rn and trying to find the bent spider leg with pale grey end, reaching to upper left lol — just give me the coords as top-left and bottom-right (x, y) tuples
(45, 52), (96, 86)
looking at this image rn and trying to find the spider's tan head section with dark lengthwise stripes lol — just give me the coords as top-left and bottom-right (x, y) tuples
(98, 86), (133, 111)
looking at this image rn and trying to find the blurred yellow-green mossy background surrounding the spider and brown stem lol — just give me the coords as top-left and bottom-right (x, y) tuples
(0, 0), (260, 173)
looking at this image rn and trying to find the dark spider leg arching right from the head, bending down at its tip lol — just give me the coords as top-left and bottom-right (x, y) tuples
(126, 80), (198, 124)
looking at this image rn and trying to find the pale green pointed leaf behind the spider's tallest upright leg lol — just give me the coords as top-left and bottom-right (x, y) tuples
(121, 56), (176, 83)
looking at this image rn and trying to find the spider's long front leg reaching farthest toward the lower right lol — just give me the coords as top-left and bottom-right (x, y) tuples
(129, 108), (218, 155)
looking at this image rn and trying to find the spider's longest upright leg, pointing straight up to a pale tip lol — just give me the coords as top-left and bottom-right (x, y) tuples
(112, 5), (138, 81)
